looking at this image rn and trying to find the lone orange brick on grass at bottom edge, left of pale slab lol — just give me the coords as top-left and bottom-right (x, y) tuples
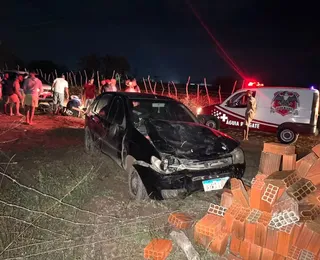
(144, 238), (172, 260)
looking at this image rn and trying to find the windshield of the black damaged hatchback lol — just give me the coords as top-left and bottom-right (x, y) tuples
(130, 99), (197, 123)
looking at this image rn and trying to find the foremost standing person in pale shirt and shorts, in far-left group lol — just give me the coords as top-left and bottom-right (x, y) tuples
(23, 71), (42, 125)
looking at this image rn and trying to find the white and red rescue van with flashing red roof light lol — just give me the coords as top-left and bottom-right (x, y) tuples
(197, 87), (319, 144)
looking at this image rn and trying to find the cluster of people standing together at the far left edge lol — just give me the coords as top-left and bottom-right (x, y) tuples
(0, 71), (42, 124)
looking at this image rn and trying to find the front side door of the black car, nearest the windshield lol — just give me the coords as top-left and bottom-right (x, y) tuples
(101, 97), (126, 160)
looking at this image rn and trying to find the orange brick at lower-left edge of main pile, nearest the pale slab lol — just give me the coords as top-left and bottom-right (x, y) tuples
(194, 214), (225, 247)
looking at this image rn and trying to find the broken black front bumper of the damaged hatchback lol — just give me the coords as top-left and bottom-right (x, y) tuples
(135, 164), (245, 199)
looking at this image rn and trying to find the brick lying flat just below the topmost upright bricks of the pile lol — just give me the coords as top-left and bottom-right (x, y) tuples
(265, 170), (301, 188)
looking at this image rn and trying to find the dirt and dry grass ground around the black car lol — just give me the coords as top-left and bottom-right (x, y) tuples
(0, 112), (319, 259)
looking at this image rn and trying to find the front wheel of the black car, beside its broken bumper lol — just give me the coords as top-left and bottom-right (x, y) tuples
(129, 167), (149, 200)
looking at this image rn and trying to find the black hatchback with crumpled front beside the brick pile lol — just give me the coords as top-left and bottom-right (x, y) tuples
(85, 92), (245, 200)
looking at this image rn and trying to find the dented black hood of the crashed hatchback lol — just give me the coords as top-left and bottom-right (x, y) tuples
(145, 119), (238, 160)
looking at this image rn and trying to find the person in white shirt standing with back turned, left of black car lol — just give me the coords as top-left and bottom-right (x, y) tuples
(52, 74), (69, 115)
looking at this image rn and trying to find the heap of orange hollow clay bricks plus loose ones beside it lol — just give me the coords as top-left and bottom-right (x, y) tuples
(145, 143), (320, 260)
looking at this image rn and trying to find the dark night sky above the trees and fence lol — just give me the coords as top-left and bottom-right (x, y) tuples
(0, 0), (320, 85)
